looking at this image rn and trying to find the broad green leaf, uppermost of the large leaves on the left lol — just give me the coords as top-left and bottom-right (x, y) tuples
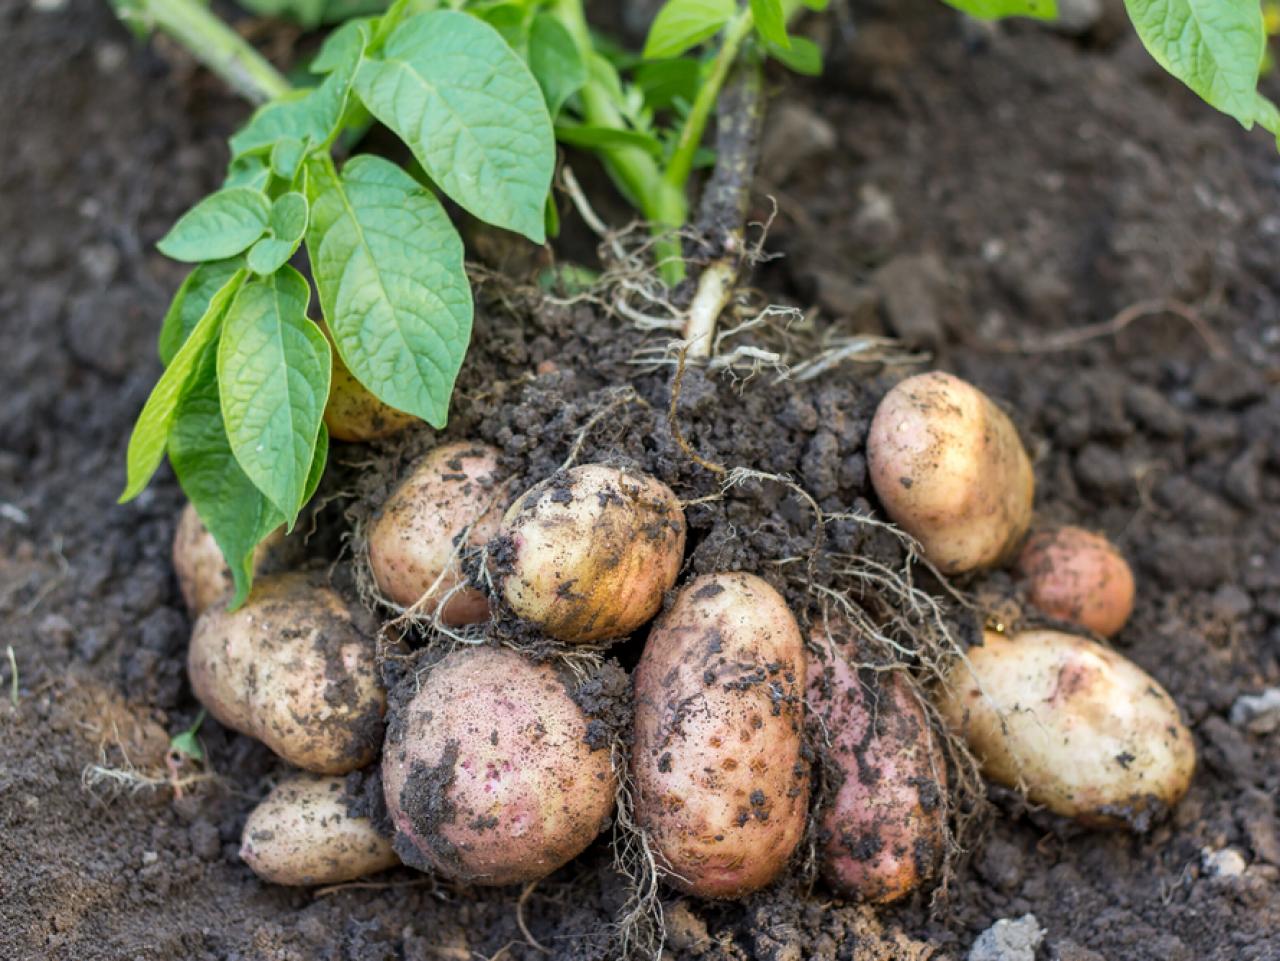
(356, 10), (556, 243)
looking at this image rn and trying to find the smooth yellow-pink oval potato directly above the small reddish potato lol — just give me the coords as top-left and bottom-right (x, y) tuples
(867, 371), (1036, 575)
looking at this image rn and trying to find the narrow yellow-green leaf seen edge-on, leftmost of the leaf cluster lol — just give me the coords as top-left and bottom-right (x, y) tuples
(120, 270), (244, 504)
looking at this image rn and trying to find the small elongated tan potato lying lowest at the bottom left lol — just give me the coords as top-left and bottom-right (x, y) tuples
(239, 773), (399, 884)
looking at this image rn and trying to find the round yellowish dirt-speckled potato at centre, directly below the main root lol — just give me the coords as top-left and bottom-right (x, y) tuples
(490, 465), (685, 644)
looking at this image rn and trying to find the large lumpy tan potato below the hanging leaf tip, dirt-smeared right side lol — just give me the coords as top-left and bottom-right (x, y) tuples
(187, 573), (387, 774)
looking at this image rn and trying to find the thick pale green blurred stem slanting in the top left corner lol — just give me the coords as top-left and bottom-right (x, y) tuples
(110, 0), (292, 104)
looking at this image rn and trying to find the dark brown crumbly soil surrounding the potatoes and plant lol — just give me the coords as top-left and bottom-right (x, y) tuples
(0, 0), (1280, 961)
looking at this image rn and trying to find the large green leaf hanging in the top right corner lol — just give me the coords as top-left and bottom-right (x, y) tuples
(1125, 0), (1266, 129)
